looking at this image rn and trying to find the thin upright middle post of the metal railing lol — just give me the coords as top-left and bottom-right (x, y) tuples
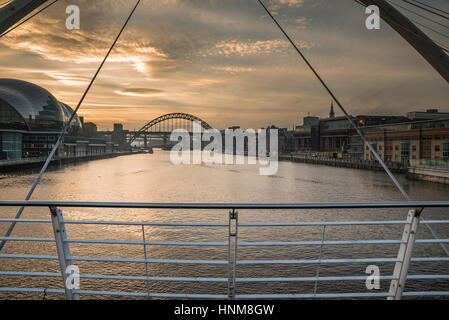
(228, 209), (239, 300)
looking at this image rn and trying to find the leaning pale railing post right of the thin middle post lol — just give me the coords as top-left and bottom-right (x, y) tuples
(388, 210), (421, 300)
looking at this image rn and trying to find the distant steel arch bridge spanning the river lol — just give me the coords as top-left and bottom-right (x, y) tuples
(128, 112), (212, 144)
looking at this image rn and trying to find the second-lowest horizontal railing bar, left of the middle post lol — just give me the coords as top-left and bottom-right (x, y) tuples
(0, 271), (228, 282)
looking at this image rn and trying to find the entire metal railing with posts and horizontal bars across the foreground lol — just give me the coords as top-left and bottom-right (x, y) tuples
(0, 201), (449, 299)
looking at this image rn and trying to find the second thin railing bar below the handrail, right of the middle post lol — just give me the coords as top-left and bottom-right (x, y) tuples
(237, 240), (404, 247)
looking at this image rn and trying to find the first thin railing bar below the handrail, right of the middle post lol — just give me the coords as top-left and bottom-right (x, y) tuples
(239, 220), (410, 227)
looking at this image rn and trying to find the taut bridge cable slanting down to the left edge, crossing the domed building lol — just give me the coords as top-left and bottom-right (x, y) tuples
(0, 0), (141, 251)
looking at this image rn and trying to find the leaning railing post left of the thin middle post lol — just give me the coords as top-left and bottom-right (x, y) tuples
(50, 207), (79, 300)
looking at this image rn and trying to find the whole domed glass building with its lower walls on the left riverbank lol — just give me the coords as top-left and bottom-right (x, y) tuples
(0, 79), (114, 160)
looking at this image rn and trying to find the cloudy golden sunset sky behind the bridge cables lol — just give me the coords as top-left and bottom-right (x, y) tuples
(0, 0), (449, 130)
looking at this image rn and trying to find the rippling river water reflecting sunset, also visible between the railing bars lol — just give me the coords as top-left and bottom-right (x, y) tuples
(0, 151), (449, 299)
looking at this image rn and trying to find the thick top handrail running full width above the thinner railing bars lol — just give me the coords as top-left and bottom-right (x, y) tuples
(0, 200), (449, 209)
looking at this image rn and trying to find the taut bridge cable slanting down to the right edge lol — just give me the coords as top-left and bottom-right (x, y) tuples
(257, 0), (449, 255)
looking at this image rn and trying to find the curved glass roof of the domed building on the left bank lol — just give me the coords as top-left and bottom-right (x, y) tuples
(0, 79), (81, 131)
